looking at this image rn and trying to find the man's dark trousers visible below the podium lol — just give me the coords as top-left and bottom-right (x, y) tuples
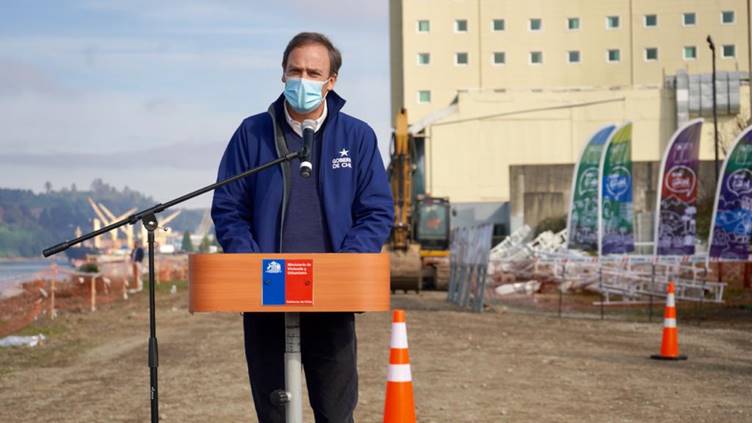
(243, 313), (358, 423)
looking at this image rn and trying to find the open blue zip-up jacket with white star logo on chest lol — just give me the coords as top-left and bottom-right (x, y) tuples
(211, 91), (394, 253)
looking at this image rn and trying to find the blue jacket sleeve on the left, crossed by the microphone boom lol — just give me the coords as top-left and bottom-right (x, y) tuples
(211, 125), (259, 253)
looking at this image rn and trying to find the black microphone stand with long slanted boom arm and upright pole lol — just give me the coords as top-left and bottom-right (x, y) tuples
(42, 147), (308, 423)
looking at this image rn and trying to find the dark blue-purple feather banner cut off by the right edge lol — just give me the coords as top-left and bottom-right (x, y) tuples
(709, 127), (752, 260)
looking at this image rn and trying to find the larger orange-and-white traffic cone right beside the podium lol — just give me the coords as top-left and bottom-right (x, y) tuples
(384, 310), (415, 423)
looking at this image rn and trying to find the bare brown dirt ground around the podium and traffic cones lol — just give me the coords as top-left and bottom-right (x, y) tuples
(0, 284), (752, 422)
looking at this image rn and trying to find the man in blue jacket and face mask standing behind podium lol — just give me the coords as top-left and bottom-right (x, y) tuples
(212, 32), (394, 423)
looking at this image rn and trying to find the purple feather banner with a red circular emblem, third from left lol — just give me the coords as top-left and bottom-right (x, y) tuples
(653, 119), (702, 256)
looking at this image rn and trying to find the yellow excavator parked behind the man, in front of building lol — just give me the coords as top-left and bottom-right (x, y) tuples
(385, 108), (451, 293)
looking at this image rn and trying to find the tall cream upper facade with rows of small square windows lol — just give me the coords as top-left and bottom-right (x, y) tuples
(390, 0), (749, 120)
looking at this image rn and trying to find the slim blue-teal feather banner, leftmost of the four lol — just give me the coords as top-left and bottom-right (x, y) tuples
(567, 125), (616, 253)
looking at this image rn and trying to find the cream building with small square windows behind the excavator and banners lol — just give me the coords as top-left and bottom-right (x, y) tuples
(390, 0), (750, 237)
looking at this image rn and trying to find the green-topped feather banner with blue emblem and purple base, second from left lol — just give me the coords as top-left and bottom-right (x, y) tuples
(598, 122), (634, 255)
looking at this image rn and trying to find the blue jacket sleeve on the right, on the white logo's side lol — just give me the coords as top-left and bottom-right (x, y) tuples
(340, 128), (394, 253)
